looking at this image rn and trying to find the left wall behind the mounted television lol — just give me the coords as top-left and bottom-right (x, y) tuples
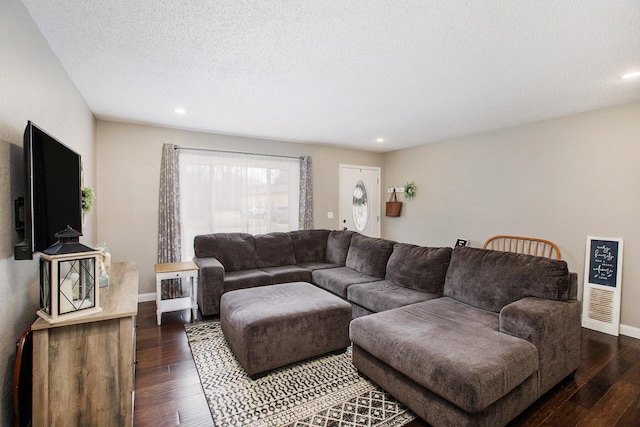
(0, 0), (96, 426)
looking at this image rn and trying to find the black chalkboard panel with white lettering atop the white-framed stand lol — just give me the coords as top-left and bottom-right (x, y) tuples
(587, 237), (622, 288)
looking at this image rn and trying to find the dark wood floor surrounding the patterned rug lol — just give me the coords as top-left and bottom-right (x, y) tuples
(134, 302), (640, 427)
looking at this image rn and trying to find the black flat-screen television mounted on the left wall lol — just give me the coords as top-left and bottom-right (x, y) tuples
(15, 121), (82, 259)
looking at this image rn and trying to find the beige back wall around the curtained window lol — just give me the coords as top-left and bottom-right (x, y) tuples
(96, 120), (382, 294)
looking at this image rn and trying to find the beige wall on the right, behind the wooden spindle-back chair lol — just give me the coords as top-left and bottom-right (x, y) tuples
(383, 103), (640, 336)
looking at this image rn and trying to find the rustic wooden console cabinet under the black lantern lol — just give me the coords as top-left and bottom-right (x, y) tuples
(31, 263), (138, 427)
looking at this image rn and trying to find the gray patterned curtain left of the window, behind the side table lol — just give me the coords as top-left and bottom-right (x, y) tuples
(158, 144), (183, 299)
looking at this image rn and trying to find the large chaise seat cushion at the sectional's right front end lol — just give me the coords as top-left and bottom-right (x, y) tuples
(350, 298), (538, 413)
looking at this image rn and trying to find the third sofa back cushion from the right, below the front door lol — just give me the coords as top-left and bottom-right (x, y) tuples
(345, 234), (395, 279)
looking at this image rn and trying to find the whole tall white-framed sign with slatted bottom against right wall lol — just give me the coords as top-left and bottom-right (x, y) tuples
(582, 236), (622, 336)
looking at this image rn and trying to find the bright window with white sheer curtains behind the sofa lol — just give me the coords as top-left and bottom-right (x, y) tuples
(180, 149), (300, 259)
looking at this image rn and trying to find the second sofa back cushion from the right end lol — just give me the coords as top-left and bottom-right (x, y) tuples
(385, 243), (453, 294)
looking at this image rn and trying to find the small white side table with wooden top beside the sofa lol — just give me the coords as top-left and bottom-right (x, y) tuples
(156, 261), (198, 326)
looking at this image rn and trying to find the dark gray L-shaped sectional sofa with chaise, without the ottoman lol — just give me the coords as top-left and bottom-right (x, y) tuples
(194, 230), (581, 426)
